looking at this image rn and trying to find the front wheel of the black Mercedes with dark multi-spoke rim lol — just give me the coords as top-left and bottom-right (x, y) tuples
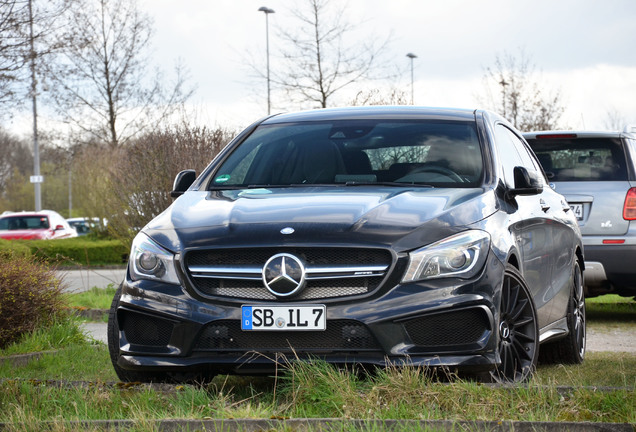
(490, 265), (539, 383)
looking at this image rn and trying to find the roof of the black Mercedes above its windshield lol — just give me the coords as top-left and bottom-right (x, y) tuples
(262, 105), (476, 124)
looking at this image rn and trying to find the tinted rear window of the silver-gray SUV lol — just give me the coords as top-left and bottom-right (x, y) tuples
(528, 138), (627, 181)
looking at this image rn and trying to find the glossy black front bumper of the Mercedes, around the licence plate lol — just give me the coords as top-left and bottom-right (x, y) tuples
(117, 259), (503, 374)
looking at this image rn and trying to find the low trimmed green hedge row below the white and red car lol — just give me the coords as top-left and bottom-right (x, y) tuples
(0, 237), (128, 266)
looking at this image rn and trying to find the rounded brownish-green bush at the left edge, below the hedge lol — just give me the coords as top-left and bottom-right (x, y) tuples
(0, 255), (66, 349)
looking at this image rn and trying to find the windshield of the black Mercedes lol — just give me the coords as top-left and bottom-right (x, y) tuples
(209, 120), (483, 189)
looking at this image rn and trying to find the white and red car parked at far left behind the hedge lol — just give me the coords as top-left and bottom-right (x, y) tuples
(0, 210), (77, 240)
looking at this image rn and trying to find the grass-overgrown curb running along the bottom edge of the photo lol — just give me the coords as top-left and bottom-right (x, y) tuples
(0, 419), (634, 432)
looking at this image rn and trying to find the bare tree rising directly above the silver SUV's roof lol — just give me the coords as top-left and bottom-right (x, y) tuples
(481, 50), (564, 131)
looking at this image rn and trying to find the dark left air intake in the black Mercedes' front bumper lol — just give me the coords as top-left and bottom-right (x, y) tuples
(119, 311), (173, 347)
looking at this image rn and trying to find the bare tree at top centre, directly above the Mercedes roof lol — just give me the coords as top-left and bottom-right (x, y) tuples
(272, 0), (384, 108)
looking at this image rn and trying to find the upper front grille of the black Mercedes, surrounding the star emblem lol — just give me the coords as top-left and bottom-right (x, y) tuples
(185, 248), (392, 301)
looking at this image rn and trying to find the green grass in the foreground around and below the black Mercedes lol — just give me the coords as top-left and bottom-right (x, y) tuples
(0, 290), (636, 431)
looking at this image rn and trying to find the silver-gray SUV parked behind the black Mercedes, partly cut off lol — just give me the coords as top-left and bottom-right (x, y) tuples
(524, 131), (636, 297)
